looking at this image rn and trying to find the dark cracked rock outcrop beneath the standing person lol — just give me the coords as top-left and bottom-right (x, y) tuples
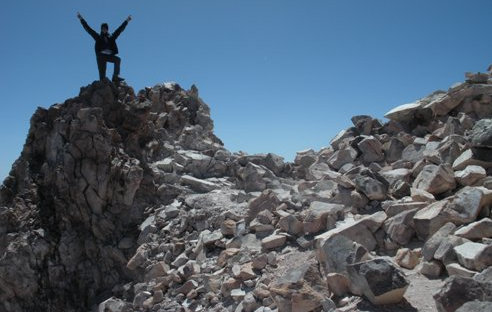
(0, 82), (221, 311)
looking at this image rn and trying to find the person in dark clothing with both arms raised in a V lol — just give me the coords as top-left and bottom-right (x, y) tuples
(77, 12), (132, 82)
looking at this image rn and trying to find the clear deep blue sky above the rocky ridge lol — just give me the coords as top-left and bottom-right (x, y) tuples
(0, 0), (492, 179)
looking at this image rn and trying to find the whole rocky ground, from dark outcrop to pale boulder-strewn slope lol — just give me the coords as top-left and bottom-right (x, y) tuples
(0, 69), (492, 312)
